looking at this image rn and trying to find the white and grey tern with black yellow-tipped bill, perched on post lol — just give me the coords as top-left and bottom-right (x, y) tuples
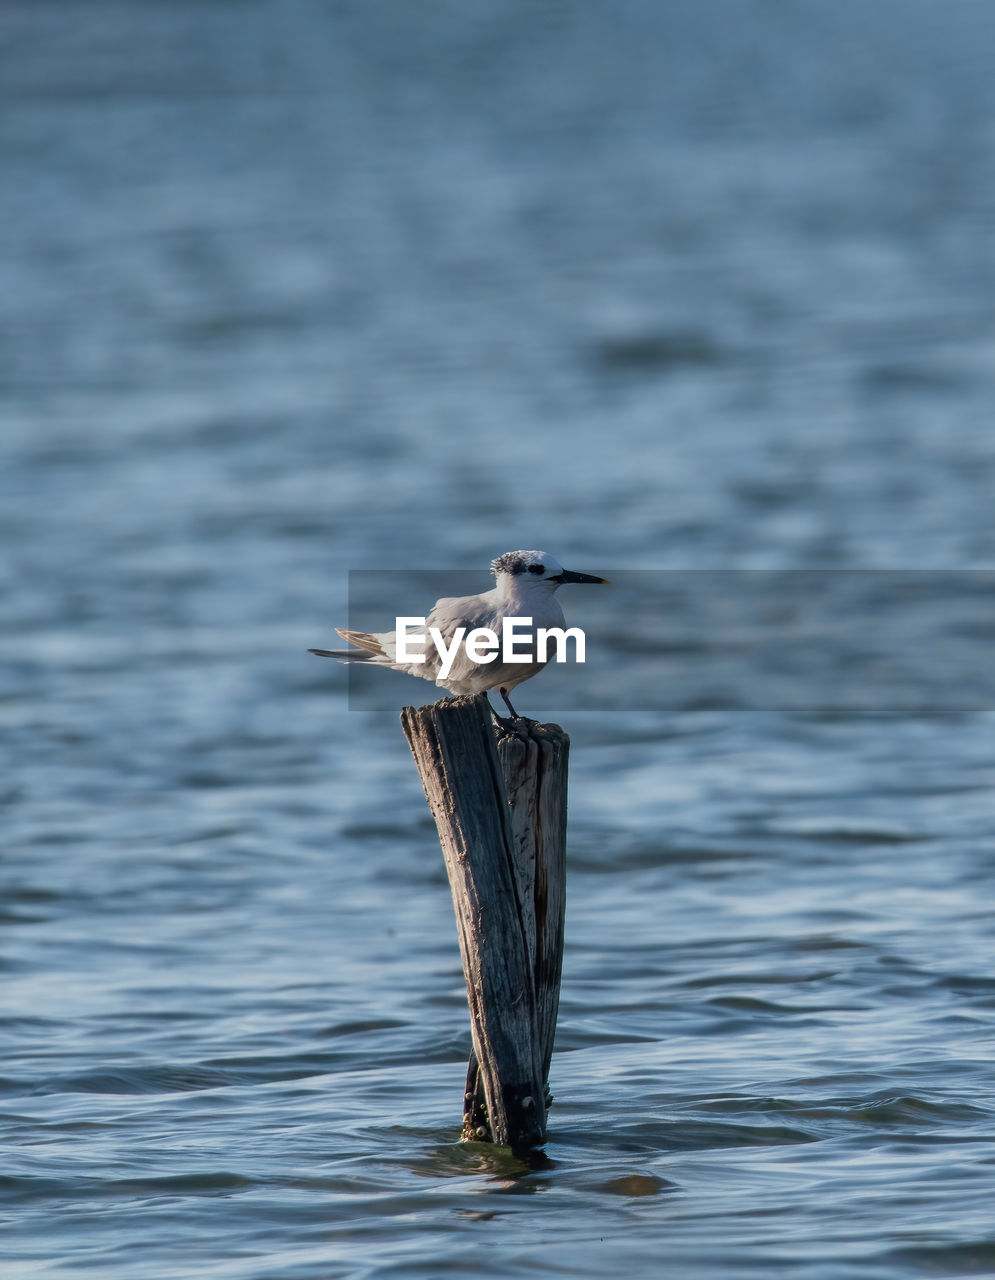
(307, 550), (608, 723)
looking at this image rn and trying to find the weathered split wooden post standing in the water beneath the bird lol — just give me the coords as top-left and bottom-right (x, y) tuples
(401, 696), (570, 1149)
